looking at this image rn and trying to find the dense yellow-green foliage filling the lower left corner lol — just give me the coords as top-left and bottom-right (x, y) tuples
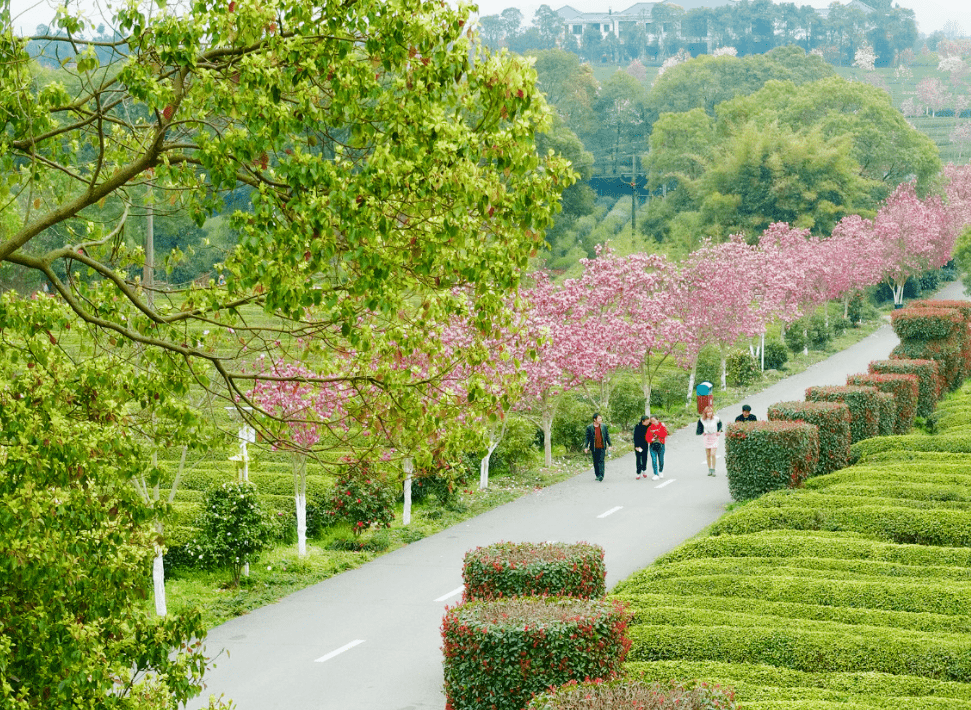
(0, 294), (213, 710)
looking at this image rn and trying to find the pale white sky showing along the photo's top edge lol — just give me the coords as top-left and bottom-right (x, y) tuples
(10, 0), (971, 35)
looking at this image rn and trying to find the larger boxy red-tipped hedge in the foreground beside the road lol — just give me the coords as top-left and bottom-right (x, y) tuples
(442, 597), (631, 710)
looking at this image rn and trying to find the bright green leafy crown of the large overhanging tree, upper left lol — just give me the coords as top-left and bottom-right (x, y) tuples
(0, 0), (572, 468)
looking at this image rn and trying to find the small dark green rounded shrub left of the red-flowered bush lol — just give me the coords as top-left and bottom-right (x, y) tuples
(188, 481), (270, 586)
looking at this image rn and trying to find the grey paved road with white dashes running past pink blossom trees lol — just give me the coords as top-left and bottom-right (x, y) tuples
(191, 283), (964, 710)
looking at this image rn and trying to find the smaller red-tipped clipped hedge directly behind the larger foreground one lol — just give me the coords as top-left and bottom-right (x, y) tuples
(462, 542), (607, 601)
